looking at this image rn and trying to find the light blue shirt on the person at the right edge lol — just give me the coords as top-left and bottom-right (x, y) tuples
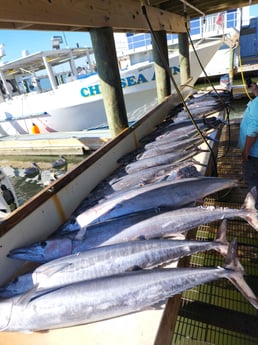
(239, 97), (258, 157)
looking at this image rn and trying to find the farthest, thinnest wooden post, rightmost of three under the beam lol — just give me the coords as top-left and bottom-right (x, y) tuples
(178, 33), (190, 84)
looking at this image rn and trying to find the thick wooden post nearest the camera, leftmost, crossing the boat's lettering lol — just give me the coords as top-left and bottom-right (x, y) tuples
(90, 27), (128, 137)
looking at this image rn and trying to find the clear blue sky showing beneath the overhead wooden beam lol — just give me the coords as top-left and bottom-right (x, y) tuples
(0, 5), (258, 61)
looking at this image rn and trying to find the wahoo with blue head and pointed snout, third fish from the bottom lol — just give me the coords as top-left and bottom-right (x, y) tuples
(8, 187), (258, 263)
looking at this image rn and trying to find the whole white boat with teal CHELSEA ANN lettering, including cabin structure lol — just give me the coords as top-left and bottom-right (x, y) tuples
(0, 40), (222, 136)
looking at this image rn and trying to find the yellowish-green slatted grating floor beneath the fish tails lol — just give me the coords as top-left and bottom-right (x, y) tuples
(171, 124), (258, 345)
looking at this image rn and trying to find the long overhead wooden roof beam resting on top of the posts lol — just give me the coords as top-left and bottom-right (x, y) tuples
(0, 0), (186, 33)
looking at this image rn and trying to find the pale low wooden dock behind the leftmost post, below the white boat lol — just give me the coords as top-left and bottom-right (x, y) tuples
(0, 129), (110, 156)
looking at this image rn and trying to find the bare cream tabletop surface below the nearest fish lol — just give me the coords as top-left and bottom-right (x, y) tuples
(0, 306), (172, 345)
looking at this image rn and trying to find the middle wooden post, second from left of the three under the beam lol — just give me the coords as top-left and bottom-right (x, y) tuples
(152, 30), (171, 103)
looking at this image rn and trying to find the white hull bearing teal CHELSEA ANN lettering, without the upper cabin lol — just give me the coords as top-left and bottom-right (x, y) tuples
(0, 41), (221, 135)
